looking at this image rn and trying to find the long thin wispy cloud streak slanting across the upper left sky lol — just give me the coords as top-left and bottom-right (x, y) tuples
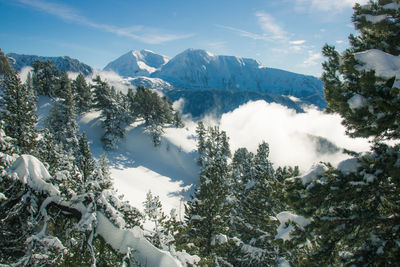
(17, 0), (193, 44)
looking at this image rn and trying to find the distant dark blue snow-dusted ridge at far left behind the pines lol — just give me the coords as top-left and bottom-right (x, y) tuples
(7, 53), (93, 75)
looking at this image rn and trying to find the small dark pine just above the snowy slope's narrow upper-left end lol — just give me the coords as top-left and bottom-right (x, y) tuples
(72, 73), (92, 113)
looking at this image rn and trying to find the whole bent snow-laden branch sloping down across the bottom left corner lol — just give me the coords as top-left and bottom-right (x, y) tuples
(8, 155), (182, 267)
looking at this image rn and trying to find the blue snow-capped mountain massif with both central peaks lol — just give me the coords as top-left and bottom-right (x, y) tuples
(104, 49), (326, 108)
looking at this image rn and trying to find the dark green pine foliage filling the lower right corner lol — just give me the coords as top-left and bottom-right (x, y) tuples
(288, 145), (400, 266)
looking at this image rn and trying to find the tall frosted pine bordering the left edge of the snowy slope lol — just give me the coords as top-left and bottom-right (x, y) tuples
(45, 73), (78, 152)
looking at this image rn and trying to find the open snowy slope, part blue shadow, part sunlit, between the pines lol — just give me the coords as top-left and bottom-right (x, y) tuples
(78, 111), (199, 219)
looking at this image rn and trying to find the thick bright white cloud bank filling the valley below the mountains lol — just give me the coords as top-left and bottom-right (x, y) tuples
(220, 101), (369, 171)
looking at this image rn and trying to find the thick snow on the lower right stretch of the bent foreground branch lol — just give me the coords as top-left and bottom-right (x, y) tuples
(96, 212), (182, 267)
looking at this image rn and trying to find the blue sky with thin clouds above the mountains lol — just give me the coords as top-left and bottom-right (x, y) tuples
(0, 0), (365, 76)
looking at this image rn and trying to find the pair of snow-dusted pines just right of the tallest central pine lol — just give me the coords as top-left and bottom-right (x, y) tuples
(232, 142), (281, 266)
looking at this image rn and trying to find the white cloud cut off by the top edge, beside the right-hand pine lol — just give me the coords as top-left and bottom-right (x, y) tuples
(294, 0), (369, 12)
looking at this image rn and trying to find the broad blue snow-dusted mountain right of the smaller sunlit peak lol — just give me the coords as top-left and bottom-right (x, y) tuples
(152, 49), (324, 106)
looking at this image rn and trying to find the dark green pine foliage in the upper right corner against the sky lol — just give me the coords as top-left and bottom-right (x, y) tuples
(322, 0), (400, 140)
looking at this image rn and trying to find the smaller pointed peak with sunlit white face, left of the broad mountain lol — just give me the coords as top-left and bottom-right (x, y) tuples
(104, 50), (169, 77)
